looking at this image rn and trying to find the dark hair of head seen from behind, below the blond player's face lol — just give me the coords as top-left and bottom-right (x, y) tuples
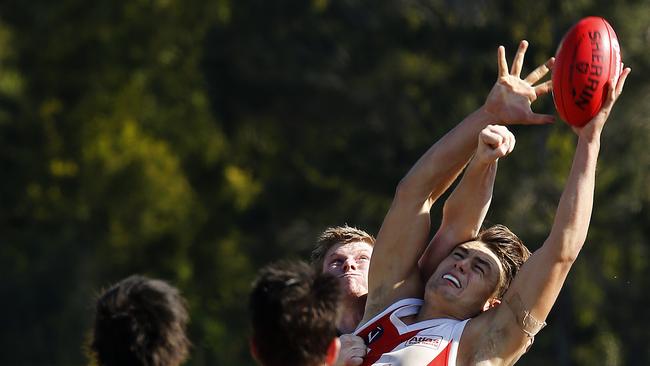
(249, 261), (339, 366)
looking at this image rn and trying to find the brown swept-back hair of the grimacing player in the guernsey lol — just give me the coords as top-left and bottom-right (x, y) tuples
(476, 225), (530, 299)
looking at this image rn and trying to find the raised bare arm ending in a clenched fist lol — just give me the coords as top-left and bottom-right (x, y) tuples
(419, 125), (515, 282)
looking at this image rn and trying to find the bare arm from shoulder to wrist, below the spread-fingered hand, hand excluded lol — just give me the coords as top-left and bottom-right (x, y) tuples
(364, 110), (490, 320)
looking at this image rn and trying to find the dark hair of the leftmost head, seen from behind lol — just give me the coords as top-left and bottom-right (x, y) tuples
(90, 275), (190, 366)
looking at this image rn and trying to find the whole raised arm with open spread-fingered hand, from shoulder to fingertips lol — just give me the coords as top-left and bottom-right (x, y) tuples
(362, 41), (554, 322)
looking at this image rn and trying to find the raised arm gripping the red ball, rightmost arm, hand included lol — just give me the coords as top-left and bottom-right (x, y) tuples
(468, 68), (630, 363)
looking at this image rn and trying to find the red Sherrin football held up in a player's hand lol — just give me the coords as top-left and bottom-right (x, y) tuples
(552, 17), (622, 126)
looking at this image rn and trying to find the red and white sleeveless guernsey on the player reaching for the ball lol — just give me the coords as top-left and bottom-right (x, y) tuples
(354, 299), (467, 366)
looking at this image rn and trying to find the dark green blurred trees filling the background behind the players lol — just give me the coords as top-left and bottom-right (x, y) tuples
(0, 0), (650, 365)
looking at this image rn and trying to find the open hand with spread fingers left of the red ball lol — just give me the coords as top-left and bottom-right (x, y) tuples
(483, 41), (555, 124)
